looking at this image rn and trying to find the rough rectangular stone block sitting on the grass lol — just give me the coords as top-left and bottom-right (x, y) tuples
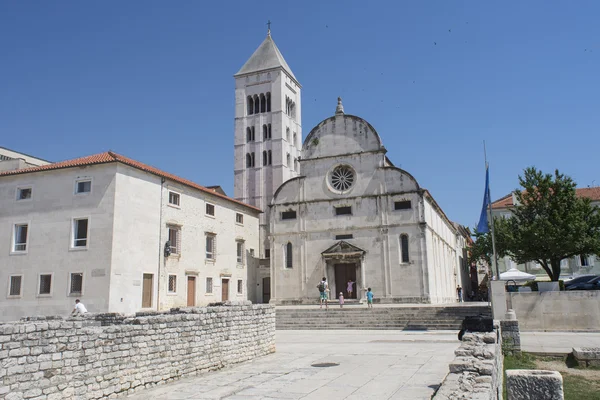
(506, 369), (565, 400)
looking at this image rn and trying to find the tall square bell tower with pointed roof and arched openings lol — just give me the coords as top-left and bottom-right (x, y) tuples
(234, 28), (302, 259)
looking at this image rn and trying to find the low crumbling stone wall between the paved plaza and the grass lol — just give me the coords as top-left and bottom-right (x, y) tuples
(433, 323), (504, 400)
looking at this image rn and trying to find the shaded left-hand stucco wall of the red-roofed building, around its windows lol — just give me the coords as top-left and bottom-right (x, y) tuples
(0, 164), (116, 320)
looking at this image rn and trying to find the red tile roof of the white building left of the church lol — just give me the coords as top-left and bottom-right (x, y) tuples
(0, 151), (262, 212)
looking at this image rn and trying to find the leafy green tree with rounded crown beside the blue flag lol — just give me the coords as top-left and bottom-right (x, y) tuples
(496, 167), (600, 281)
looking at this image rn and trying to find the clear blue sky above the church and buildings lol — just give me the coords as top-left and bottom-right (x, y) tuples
(0, 0), (600, 227)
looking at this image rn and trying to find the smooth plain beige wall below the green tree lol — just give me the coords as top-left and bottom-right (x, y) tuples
(508, 290), (600, 332)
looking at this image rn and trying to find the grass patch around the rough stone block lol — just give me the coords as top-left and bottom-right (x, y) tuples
(503, 353), (600, 400)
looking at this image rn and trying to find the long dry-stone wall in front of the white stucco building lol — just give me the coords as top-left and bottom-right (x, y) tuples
(0, 302), (275, 400)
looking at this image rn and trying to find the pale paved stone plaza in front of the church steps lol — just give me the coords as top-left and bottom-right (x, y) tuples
(128, 331), (460, 400)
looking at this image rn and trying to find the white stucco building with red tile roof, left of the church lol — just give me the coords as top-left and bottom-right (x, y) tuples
(0, 152), (260, 320)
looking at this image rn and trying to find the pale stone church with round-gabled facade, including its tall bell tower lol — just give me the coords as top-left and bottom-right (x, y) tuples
(234, 32), (469, 304)
